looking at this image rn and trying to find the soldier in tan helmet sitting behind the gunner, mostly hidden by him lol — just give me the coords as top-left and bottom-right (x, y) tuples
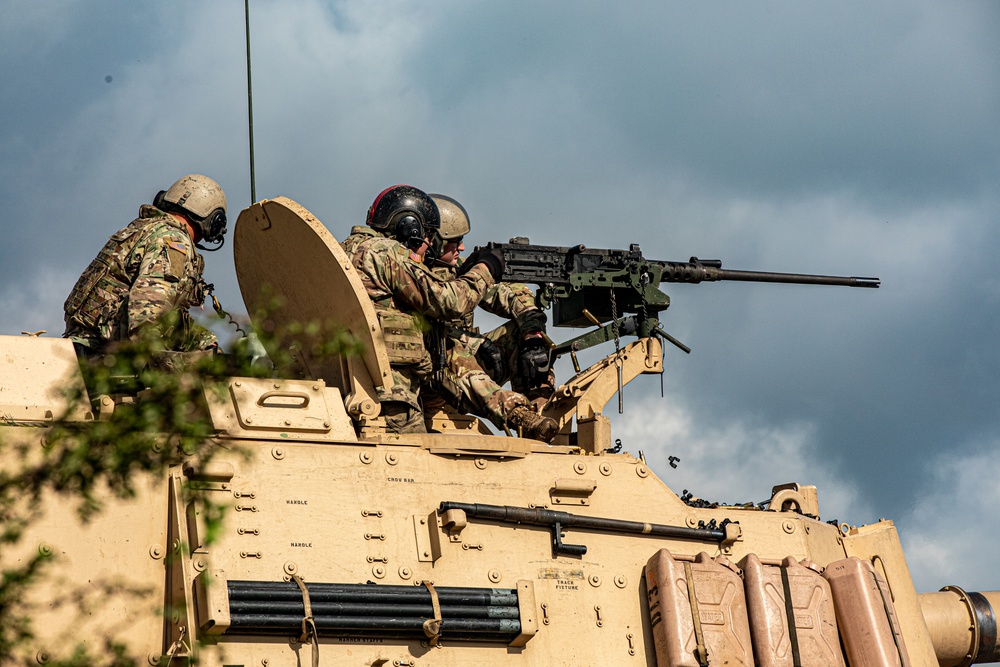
(424, 194), (559, 442)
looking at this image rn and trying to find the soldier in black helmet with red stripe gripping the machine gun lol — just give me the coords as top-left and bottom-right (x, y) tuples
(343, 185), (503, 433)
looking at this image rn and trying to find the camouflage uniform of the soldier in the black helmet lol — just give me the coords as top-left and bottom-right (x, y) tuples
(343, 226), (494, 433)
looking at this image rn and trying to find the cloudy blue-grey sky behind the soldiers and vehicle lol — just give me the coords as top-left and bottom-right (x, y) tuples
(0, 0), (1000, 590)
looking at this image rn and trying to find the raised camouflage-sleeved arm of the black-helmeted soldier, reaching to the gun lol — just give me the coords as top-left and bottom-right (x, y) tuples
(377, 248), (494, 320)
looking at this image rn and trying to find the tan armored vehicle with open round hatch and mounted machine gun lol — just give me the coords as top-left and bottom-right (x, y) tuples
(0, 198), (1000, 667)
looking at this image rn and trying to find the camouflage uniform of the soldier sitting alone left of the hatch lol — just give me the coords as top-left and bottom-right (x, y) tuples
(63, 205), (217, 353)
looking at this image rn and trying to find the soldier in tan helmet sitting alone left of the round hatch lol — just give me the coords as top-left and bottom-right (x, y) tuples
(63, 174), (226, 355)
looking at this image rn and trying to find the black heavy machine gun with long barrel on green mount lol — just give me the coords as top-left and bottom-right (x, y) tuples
(487, 237), (879, 356)
